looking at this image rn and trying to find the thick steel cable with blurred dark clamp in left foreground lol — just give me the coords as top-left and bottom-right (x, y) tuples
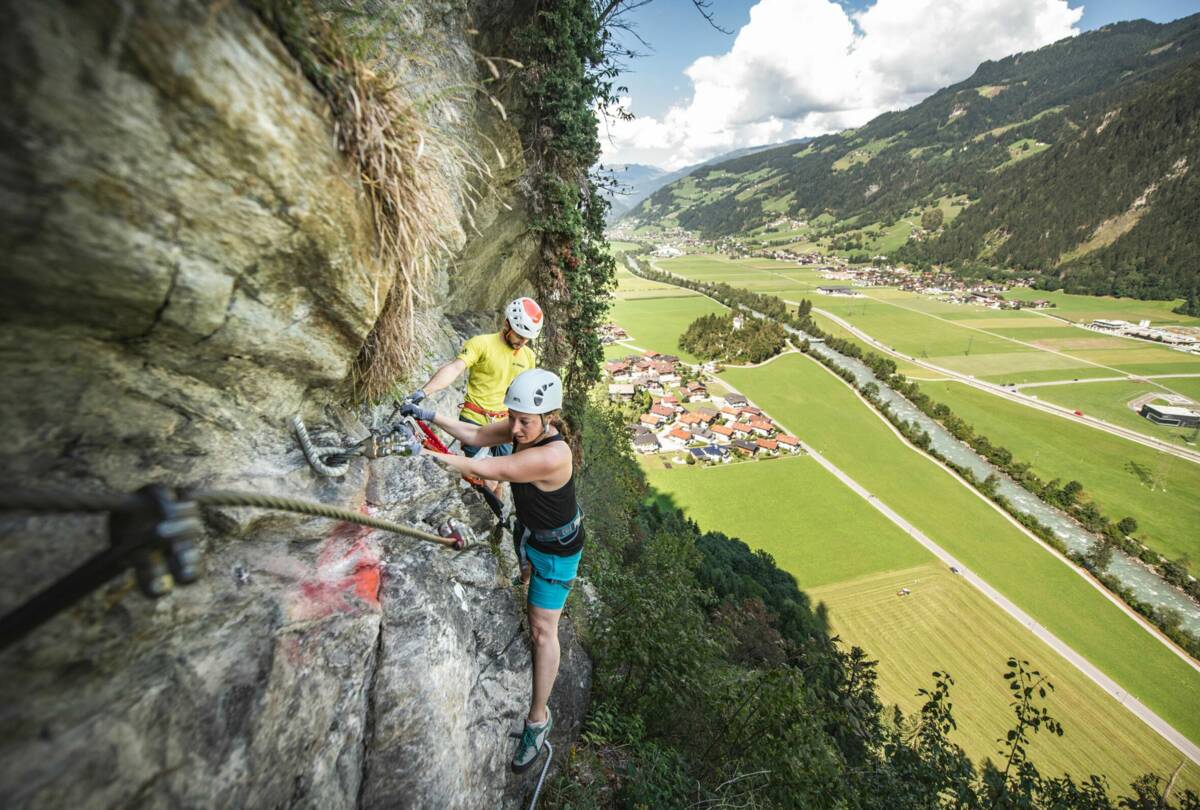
(0, 485), (467, 649)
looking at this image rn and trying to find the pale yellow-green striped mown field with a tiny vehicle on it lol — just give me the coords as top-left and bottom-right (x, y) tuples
(809, 564), (1200, 788)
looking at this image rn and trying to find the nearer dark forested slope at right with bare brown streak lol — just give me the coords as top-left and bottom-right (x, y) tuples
(898, 60), (1200, 298)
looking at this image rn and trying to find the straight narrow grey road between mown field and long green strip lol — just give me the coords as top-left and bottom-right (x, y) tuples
(718, 369), (1200, 764)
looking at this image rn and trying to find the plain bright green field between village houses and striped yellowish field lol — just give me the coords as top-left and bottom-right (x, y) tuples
(642, 456), (932, 589)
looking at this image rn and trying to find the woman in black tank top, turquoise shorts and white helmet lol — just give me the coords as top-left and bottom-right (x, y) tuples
(401, 368), (584, 773)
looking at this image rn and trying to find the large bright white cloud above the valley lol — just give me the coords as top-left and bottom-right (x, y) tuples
(601, 0), (1082, 169)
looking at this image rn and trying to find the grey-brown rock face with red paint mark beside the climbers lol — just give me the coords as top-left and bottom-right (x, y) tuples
(0, 0), (589, 808)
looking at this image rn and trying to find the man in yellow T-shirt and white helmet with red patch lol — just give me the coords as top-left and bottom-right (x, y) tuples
(406, 298), (542, 496)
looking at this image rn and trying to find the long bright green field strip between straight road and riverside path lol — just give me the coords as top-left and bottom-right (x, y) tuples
(722, 354), (1200, 740)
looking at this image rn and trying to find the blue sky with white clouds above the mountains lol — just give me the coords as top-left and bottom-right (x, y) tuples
(605, 0), (1200, 168)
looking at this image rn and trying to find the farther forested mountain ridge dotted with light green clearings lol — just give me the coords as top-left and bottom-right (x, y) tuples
(628, 14), (1200, 294)
